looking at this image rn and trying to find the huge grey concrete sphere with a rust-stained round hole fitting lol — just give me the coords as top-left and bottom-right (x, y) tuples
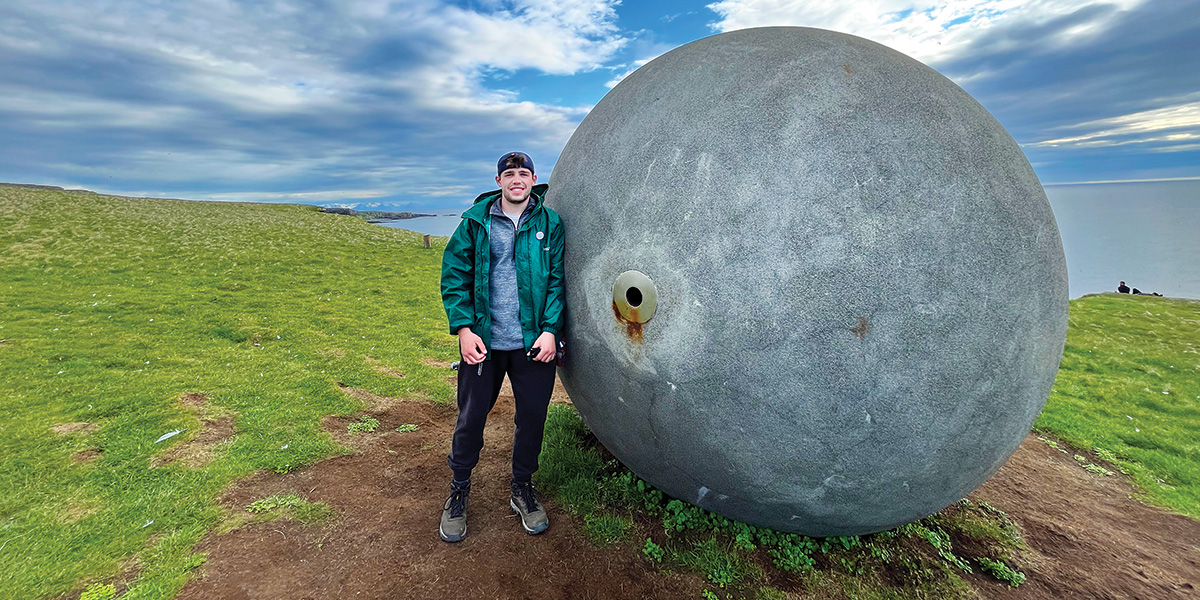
(547, 28), (1067, 536)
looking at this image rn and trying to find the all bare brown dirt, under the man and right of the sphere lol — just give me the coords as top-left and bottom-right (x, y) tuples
(179, 379), (1200, 600)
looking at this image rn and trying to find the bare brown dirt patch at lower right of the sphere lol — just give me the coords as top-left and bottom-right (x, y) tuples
(971, 434), (1200, 600)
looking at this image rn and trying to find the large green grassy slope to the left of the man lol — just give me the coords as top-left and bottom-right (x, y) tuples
(0, 187), (456, 599)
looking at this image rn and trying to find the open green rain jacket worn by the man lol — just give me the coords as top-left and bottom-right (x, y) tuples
(442, 184), (564, 359)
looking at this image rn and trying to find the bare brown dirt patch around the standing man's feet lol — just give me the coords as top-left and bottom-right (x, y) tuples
(179, 379), (703, 600)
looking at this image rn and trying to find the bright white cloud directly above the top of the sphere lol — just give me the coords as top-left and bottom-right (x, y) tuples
(708, 0), (1145, 64)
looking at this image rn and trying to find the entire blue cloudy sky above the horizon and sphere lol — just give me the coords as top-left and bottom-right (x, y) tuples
(0, 0), (1200, 209)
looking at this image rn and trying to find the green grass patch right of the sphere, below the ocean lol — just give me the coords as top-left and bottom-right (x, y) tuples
(1036, 294), (1200, 518)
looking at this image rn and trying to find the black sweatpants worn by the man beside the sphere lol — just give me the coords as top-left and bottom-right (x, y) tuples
(446, 349), (554, 481)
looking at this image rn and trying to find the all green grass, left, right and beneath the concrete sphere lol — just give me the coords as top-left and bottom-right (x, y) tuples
(0, 186), (1200, 599)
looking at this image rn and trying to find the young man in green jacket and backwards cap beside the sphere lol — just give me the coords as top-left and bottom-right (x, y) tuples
(438, 152), (563, 541)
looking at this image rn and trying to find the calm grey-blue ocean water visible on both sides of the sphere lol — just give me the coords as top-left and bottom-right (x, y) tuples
(382, 181), (1200, 299)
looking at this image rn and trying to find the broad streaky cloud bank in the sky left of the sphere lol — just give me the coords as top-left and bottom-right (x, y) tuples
(0, 0), (626, 198)
